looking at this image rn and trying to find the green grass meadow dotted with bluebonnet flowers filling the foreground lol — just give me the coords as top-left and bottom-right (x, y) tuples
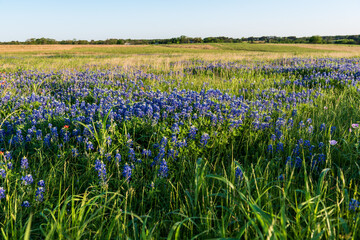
(0, 45), (360, 239)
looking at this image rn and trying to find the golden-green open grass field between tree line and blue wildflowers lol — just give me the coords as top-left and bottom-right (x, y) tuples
(0, 43), (360, 71)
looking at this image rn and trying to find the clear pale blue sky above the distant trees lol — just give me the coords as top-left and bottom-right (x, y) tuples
(0, 0), (360, 41)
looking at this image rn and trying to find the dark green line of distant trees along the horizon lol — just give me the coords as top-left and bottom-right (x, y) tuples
(0, 35), (360, 45)
